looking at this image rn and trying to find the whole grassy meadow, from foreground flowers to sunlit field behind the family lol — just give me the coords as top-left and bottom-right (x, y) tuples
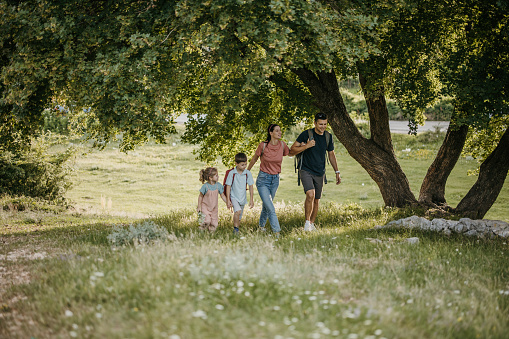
(0, 126), (509, 339)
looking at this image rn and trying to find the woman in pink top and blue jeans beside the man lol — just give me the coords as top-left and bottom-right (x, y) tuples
(247, 124), (290, 237)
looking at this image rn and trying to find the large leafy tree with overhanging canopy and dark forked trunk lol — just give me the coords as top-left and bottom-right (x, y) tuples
(0, 0), (509, 217)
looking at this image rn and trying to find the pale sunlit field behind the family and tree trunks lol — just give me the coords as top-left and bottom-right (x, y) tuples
(67, 129), (509, 221)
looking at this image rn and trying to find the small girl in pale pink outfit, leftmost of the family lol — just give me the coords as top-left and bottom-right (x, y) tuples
(196, 167), (226, 232)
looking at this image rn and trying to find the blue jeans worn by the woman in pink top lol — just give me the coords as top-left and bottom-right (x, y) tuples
(256, 171), (281, 232)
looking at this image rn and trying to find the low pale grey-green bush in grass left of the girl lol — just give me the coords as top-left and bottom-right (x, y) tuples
(108, 221), (170, 246)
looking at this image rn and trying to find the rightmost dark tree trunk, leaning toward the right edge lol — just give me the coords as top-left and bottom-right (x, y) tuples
(455, 128), (509, 219)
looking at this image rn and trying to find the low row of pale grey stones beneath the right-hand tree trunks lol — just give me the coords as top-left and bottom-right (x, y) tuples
(375, 215), (509, 238)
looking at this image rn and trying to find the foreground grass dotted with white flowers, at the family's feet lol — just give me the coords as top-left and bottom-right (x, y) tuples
(0, 204), (509, 338)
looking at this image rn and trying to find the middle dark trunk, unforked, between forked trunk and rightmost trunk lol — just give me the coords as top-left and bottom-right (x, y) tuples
(419, 123), (468, 205)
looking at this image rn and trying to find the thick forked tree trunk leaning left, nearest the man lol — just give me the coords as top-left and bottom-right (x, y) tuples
(293, 68), (417, 207)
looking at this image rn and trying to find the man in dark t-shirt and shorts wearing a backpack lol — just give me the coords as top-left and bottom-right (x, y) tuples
(290, 113), (341, 231)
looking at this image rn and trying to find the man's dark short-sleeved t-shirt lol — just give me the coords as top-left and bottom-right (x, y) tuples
(297, 128), (334, 176)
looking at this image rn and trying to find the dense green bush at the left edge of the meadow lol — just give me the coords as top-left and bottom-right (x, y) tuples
(0, 137), (76, 200)
